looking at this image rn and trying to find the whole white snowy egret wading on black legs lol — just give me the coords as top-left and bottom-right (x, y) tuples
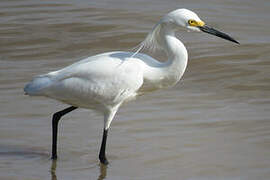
(24, 9), (238, 164)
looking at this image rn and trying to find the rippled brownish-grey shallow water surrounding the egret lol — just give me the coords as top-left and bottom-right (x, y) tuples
(0, 0), (270, 180)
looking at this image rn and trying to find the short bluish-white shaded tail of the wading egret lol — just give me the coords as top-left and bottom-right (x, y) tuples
(24, 76), (52, 96)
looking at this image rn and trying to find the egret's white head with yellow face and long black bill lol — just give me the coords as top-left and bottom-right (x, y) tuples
(161, 9), (239, 44)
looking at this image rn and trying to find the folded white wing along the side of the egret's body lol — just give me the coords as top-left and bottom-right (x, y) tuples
(39, 53), (143, 106)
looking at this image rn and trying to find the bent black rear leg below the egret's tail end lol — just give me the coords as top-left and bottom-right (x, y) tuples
(52, 106), (78, 159)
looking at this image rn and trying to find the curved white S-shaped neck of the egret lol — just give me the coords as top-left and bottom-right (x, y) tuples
(142, 24), (188, 88)
